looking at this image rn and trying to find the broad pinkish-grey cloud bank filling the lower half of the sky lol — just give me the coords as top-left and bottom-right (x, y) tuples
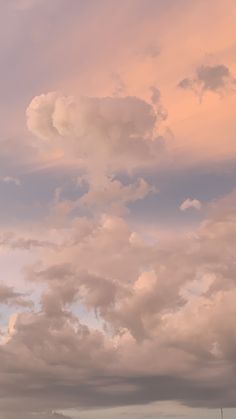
(0, 191), (236, 418)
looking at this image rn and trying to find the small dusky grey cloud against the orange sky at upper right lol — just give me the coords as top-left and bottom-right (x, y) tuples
(178, 64), (236, 99)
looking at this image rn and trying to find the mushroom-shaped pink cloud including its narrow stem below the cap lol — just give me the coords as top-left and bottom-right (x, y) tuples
(26, 88), (166, 215)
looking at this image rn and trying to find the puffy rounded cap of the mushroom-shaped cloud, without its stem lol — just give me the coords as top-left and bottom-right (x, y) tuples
(26, 92), (168, 171)
